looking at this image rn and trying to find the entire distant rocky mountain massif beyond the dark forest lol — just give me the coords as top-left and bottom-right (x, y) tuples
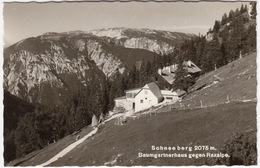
(3, 28), (193, 105)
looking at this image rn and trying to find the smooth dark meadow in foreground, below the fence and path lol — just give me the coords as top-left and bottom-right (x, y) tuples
(48, 102), (256, 166)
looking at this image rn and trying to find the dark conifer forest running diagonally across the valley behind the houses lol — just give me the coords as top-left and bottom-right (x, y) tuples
(4, 2), (256, 162)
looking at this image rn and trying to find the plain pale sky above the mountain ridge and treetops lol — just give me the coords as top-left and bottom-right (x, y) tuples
(3, 2), (249, 47)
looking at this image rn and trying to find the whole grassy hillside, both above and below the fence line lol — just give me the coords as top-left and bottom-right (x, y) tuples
(17, 53), (256, 166)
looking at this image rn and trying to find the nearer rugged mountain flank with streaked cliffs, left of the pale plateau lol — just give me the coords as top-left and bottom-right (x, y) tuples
(4, 35), (123, 105)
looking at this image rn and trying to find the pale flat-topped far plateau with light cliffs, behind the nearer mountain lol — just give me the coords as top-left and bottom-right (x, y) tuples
(89, 28), (195, 54)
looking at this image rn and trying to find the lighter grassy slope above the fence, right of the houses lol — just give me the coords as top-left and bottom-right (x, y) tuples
(175, 53), (257, 108)
